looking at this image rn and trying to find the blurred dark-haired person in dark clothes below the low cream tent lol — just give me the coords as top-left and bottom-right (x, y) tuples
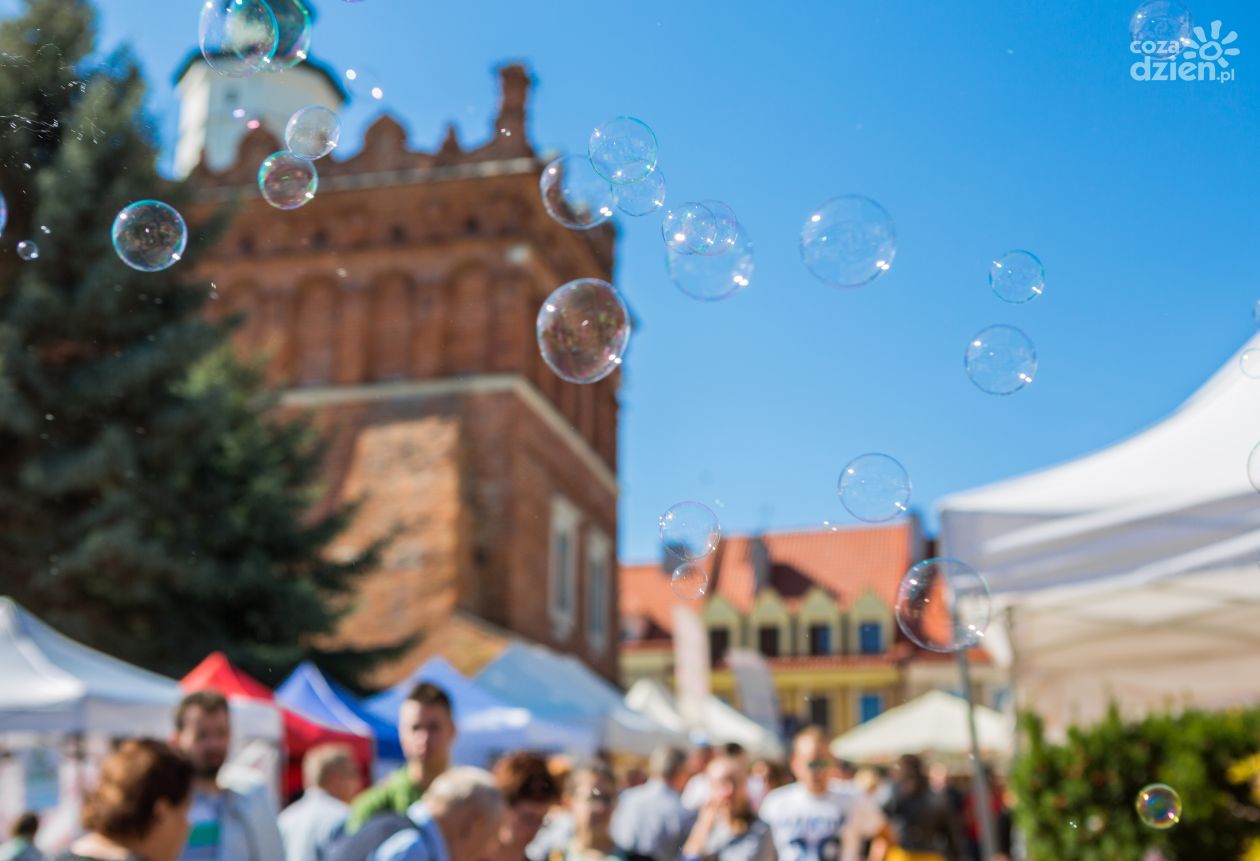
(885, 754), (964, 861)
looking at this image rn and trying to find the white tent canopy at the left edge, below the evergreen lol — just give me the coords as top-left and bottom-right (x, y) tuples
(0, 598), (181, 737)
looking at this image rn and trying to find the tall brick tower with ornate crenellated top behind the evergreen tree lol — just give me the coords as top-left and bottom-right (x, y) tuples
(183, 66), (619, 683)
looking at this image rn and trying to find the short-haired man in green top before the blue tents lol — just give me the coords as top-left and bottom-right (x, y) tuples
(345, 682), (455, 833)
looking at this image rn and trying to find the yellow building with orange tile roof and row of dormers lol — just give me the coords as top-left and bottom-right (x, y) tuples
(620, 518), (998, 735)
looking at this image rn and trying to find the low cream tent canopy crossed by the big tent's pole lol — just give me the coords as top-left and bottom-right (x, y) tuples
(832, 691), (1012, 763)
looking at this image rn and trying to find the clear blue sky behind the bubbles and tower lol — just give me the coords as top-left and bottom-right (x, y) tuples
(86, 0), (1260, 560)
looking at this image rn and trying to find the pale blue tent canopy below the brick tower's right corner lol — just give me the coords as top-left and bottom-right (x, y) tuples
(473, 643), (687, 756)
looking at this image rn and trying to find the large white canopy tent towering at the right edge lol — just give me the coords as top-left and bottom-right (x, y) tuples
(940, 335), (1260, 729)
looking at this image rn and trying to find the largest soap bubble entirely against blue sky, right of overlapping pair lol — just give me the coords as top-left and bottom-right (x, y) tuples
(800, 194), (897, 287)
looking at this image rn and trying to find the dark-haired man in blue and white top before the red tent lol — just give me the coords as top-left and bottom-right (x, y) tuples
(171, 691), (285, 861)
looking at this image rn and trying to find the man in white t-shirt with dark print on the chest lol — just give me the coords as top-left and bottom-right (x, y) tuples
(759, 726), (888, 861)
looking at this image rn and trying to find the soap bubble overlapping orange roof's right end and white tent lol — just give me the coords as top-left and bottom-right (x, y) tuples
(896, 558), (993, 652)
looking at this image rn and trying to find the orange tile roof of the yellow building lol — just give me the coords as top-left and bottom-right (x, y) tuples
(619, 518), (922, 640)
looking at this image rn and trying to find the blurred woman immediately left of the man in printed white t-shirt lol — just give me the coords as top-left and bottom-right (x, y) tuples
(683, 756), (775, 861)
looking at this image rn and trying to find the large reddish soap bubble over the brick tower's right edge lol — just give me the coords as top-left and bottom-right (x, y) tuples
(536, 279), (630, 383)
